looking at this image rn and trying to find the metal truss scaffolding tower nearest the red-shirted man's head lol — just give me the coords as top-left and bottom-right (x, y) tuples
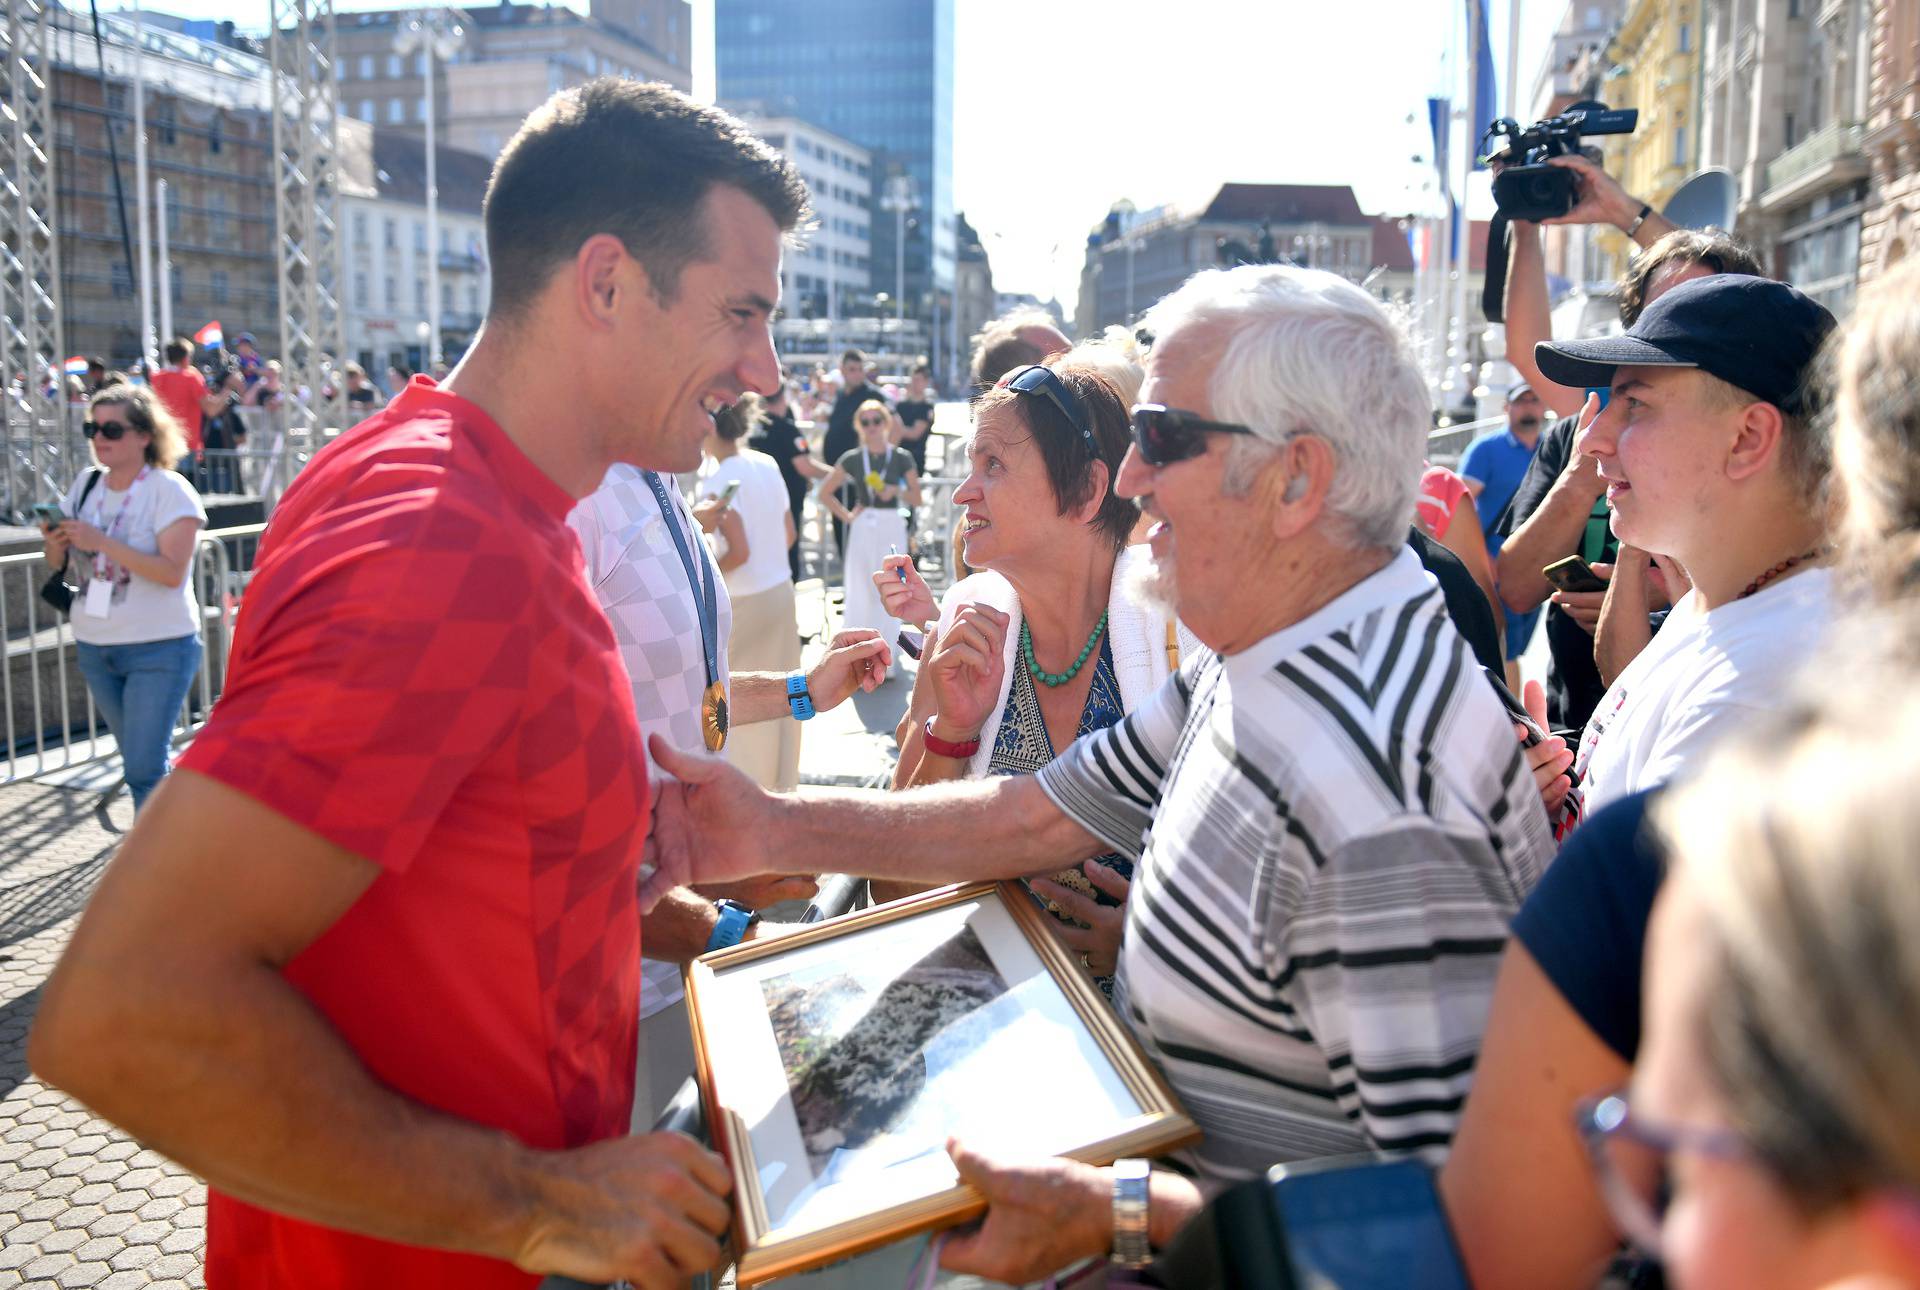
(268, 0), (346, 430)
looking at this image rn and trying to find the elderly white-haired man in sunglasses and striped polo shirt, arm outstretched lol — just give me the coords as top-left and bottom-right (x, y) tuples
(655, 267), (1553, 1280)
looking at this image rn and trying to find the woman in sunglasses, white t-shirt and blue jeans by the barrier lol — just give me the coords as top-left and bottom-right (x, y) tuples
(44, 386), (207, 810)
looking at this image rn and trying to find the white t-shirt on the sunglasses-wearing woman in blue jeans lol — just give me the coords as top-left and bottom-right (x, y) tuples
(60, 466), (207, 645)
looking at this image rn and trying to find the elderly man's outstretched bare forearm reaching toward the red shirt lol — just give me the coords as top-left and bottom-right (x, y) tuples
(768, 776), (1106, 883)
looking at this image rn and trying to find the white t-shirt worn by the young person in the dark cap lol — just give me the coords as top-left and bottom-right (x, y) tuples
(1576, 568), (1834, 812)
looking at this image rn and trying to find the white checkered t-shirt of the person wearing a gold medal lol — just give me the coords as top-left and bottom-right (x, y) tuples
(566, 465), (729, 1017)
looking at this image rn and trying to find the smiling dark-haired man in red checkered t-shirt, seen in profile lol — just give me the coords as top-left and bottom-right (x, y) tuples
(29, 79), (806, 1290)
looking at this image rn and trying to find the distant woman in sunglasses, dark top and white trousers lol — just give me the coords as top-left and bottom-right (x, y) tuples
(814, 399), (920, 656)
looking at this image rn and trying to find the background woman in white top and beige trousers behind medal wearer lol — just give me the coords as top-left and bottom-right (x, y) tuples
(693, 395), (801, 791)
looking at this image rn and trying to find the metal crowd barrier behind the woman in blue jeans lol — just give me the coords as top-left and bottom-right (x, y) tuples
(0, 524), (267, 783)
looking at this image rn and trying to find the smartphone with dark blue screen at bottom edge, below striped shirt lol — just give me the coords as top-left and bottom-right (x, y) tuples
(1267, 1158), (1469, 1290)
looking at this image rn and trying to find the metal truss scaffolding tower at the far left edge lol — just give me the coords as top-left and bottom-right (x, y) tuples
(0, 0), (65, 436)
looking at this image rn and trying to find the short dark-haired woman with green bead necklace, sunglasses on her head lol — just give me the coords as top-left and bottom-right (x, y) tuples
(874, 351), (1198, 985)
